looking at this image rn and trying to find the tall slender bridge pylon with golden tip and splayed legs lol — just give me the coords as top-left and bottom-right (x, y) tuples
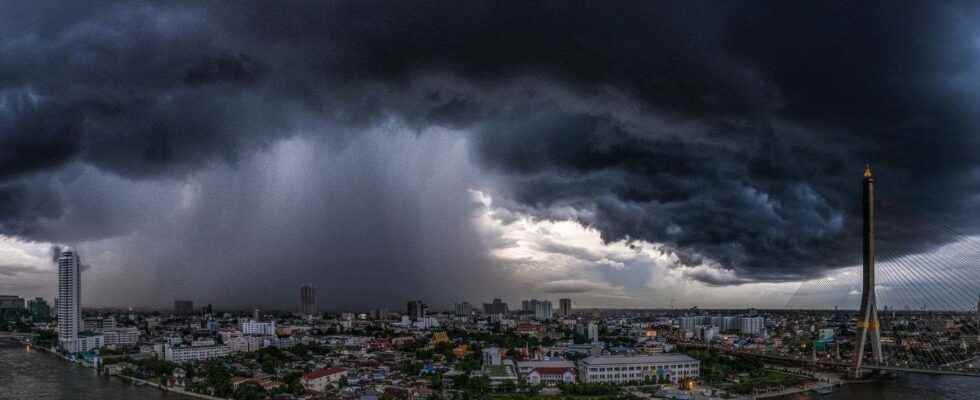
(852, 166), (882, 377)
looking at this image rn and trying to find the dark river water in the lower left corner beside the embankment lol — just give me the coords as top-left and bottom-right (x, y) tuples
(0, 339), (193, 400)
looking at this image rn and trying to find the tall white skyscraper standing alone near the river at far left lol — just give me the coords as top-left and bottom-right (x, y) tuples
(58, 249), (82, 353)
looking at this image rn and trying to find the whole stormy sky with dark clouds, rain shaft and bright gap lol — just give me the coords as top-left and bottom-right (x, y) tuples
(0, 1), (980, 310)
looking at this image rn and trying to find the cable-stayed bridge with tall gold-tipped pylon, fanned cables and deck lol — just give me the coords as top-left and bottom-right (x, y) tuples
(776, 168), (980, 378)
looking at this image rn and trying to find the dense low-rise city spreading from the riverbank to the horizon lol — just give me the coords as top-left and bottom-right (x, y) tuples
(0, 251), (978, 400)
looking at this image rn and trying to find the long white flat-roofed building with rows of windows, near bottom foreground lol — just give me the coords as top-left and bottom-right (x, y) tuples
(579, 353), (701, 384)
